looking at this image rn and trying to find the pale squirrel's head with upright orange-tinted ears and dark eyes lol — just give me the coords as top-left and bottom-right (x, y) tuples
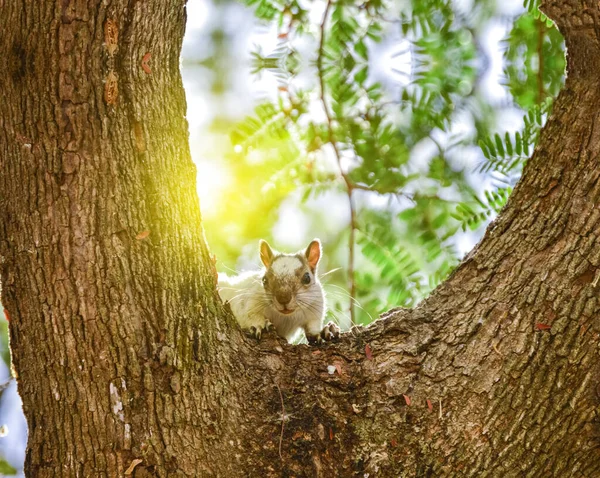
(260, 239), (323, 315)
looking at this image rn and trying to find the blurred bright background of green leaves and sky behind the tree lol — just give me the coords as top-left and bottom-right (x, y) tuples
(0, 0), (565, 475)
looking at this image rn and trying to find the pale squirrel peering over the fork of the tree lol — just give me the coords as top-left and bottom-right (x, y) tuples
(218, 239), (340, 345)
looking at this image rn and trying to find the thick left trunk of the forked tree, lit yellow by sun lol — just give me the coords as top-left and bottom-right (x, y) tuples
(0, 0), (248, 477)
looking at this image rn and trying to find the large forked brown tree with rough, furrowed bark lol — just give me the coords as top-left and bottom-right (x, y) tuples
(0, 0), (600, 477)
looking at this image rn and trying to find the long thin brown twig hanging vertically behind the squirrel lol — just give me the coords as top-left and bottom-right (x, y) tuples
(317, 0), (356, 323)
